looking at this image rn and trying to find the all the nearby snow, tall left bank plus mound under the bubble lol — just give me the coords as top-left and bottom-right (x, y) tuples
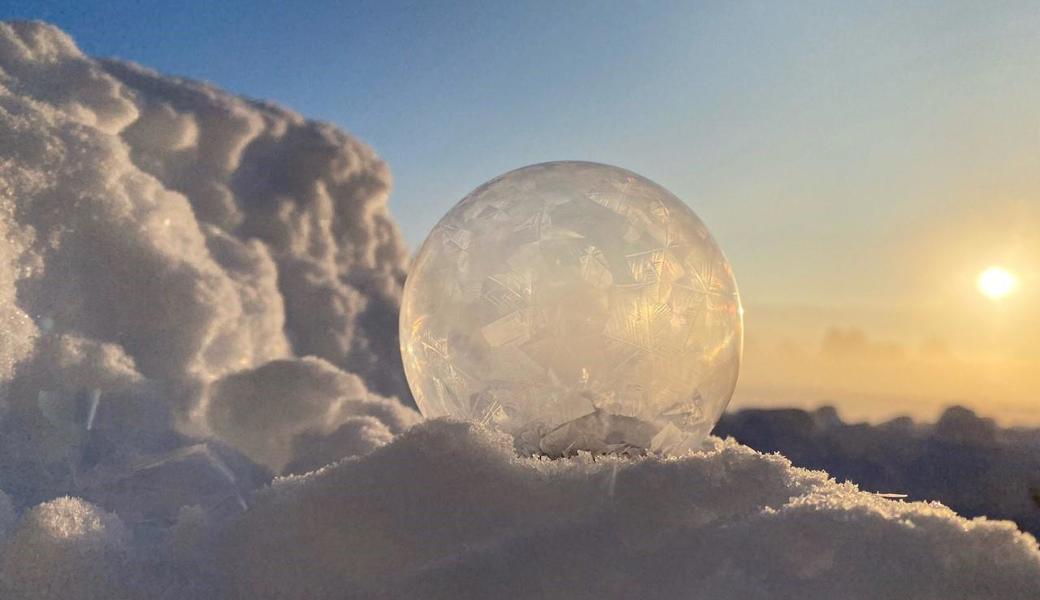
(0, 23), (1040, 600)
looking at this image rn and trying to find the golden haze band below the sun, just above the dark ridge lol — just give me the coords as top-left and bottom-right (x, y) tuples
(731, 320), (1040, 426)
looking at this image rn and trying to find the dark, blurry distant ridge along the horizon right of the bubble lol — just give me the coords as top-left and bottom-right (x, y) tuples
(714, 407), (1040, 534)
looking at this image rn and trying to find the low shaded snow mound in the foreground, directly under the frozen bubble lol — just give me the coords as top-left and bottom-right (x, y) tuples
(219, 421), (1040, 599)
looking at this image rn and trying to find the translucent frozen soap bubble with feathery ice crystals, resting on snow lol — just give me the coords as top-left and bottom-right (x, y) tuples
(400, 161), (743, 456)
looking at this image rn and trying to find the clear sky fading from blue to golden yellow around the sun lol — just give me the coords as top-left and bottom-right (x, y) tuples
(8, 0), (1040, 422)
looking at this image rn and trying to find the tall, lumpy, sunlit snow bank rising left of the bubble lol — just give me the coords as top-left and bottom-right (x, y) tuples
(0, 22), (417, 488)
